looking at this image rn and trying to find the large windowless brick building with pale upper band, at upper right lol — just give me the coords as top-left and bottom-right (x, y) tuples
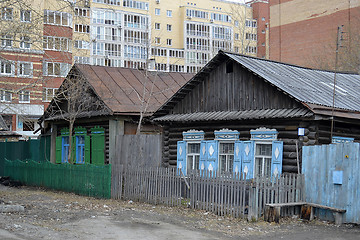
(269, 0), (360, 69)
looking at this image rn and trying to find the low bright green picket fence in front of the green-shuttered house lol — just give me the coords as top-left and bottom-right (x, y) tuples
(4, 160), (111, 198)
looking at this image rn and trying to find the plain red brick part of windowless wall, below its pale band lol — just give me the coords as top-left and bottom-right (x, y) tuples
(270, 0), (360, 68)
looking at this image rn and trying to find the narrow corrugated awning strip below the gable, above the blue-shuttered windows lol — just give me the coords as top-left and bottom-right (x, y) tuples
(154, 108), (313, 122)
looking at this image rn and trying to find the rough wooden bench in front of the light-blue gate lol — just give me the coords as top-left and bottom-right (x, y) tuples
(264, 202), (346, 225)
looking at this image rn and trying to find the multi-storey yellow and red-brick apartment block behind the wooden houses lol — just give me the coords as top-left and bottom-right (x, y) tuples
(0, 0), (258, 134)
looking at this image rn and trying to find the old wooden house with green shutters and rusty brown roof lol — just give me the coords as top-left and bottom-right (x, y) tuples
(40, 64), (193, 164)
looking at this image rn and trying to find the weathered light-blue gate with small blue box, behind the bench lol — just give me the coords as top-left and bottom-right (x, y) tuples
(302, 143), (360, 223)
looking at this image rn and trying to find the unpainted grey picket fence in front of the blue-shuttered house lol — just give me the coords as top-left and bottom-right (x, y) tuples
(112, 167), (305, 220)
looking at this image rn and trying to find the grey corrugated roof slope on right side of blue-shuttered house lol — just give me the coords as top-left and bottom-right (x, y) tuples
(223, 52), (360, 111)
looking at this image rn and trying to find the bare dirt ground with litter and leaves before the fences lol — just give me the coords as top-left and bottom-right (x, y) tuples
(0, 185), (360, 240)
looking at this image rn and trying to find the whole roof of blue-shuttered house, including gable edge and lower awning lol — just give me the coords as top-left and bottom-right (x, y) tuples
(154, 51), (360, 121)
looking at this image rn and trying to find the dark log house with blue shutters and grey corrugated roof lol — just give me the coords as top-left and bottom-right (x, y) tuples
(153, 51), (360, 176)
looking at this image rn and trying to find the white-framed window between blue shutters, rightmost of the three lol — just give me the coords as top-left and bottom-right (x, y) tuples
(254, 143), (272, 177)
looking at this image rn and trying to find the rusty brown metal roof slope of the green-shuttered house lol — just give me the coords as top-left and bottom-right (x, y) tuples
(75, 64), (194, 113)
